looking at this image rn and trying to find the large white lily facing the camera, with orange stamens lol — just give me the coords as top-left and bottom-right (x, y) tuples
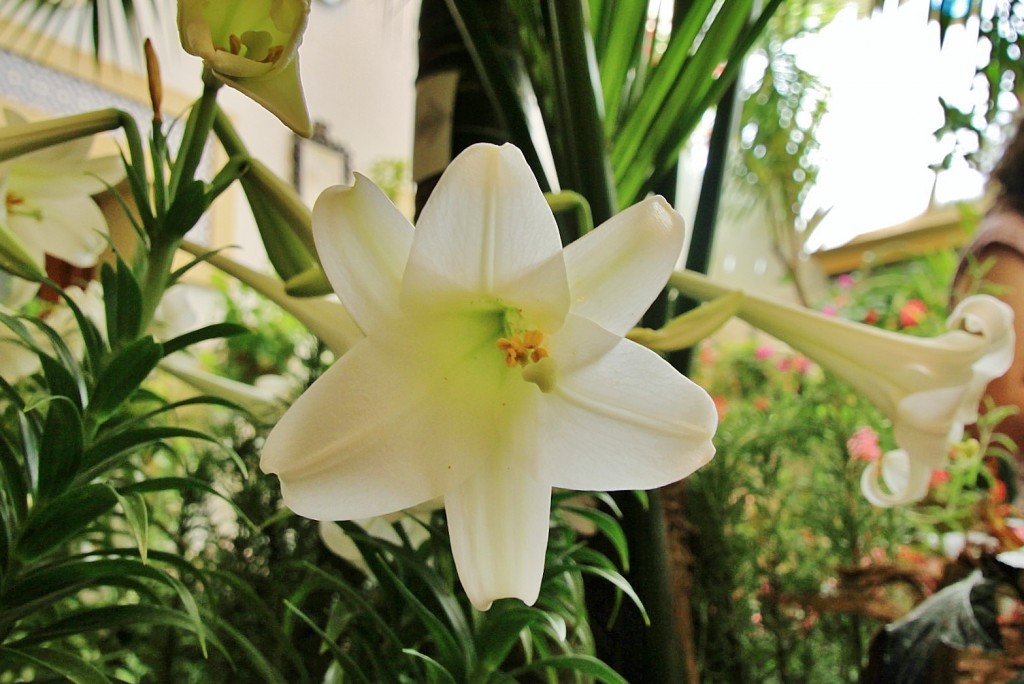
(260, 144), (717, 609)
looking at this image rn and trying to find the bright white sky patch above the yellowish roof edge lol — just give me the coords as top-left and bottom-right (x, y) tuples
(794, 0), (983, 252)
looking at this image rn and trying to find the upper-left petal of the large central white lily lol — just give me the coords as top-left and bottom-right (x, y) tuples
(312, 174), (413, 335)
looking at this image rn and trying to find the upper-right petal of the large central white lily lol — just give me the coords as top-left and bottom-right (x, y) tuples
(565, 197), (685, 335)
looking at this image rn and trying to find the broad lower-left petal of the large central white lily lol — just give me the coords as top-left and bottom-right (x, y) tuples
(260, 322), (505, 520)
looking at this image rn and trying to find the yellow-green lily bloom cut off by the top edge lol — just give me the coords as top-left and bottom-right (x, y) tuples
(178, 0), (312, 137)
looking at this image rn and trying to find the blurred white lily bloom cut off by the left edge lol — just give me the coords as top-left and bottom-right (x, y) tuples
(0, 110), (125, 268)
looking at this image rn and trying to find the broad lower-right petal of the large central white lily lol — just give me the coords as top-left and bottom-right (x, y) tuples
(534, 316), (718, 490)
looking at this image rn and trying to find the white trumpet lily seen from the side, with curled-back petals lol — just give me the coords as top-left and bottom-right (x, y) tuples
(670, 271), (1014, 506)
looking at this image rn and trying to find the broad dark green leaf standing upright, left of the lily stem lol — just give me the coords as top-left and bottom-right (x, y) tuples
(38, 396), (85, 500)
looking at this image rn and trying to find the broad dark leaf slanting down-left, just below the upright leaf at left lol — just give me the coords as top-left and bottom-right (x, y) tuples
(14, 484), (118, 561)
